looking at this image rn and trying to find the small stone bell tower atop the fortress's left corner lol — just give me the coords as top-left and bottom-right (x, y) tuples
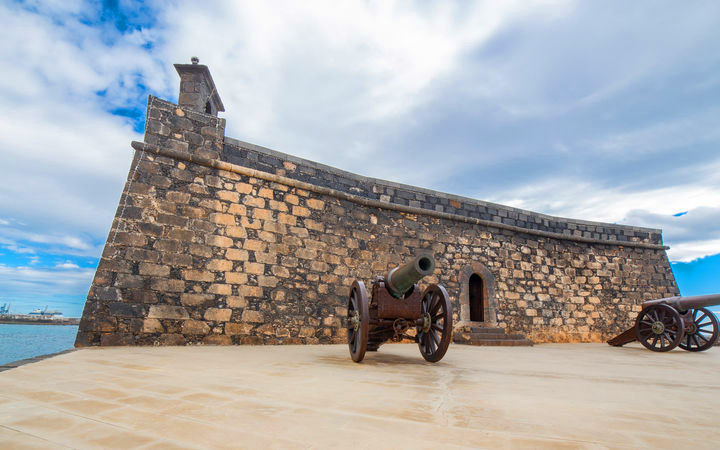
(175, 56), (225, 116)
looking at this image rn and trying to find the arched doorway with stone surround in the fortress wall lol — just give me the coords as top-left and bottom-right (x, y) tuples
(458, 262), (497, 326)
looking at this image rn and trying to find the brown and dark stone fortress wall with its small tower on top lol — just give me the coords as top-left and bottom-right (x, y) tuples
(76, 64), (678, 346)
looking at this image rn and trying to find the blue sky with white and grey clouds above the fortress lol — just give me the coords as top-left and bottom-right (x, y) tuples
(0, 0), (720, 315)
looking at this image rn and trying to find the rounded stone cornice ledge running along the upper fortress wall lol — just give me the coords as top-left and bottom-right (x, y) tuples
(131, 141), (670, 250)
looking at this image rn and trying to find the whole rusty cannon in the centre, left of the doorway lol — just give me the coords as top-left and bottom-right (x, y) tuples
(347, 255), (452, 362)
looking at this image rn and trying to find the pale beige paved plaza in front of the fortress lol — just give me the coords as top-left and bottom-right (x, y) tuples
(0, 344), (720, 448)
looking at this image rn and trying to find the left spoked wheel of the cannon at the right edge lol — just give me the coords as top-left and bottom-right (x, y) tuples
(635, 304), (685, 352)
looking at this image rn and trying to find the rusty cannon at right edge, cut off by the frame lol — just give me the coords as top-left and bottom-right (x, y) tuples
(608, 294), (720, 352)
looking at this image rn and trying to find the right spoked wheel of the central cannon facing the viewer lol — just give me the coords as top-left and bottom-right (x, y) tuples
(417, 284), (452, 362)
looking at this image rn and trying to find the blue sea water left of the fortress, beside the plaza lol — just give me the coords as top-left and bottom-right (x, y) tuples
(0, 324), (78, 365)
